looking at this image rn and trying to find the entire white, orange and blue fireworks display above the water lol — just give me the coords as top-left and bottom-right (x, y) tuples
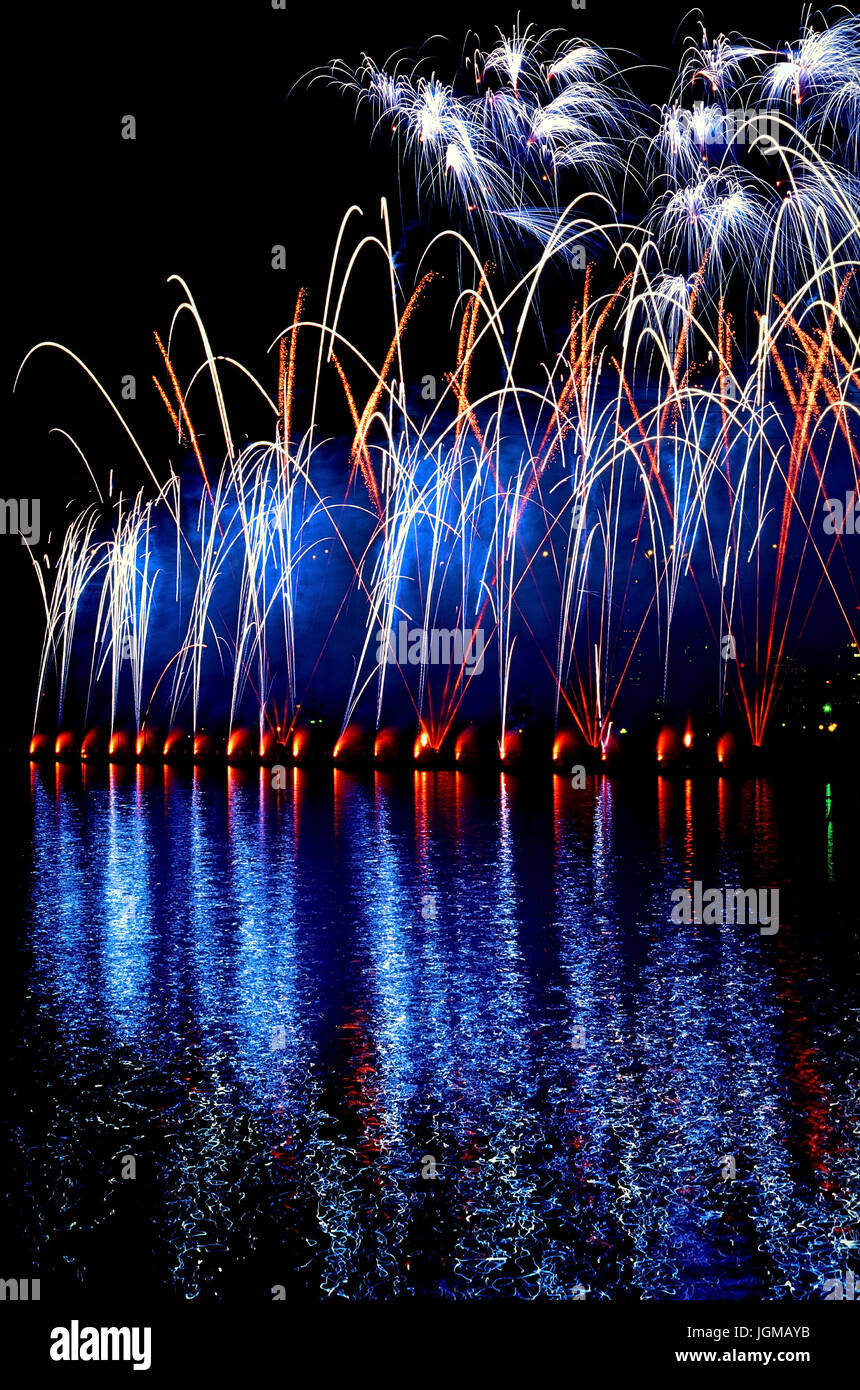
(16, 19), (860, 760)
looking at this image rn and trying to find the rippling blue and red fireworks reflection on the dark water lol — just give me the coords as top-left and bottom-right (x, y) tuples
(10, 766), (860, 1298)
